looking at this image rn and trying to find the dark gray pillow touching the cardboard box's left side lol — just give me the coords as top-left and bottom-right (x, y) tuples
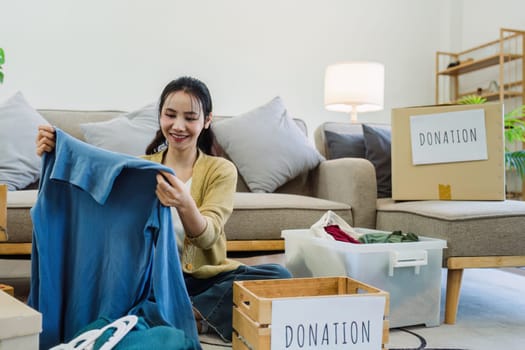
(363, 124), (392, 198)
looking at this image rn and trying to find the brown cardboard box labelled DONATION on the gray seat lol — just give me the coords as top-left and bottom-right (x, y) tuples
(391, 103), (505, 200)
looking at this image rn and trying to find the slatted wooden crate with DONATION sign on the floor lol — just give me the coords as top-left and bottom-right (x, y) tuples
(232, 277), (389, 350)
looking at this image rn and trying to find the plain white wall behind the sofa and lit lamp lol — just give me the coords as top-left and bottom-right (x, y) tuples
(0, 0), (525, 133)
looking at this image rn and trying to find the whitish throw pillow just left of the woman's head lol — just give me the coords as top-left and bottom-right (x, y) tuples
(80, 103), (159, 156)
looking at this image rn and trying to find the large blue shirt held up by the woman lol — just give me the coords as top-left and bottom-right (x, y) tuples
(28, 129), (198, 349)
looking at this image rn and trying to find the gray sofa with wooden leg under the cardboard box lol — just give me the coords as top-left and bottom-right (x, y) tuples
(314, 122), (525, 324)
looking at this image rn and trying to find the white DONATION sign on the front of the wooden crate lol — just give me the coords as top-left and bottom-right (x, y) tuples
(271, 295), (385, 350)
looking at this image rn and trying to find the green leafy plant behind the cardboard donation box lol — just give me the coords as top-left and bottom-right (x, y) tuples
(457, 95), (525, 185)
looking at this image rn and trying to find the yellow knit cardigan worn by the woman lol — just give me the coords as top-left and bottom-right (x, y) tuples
(142, 150), (241, 278)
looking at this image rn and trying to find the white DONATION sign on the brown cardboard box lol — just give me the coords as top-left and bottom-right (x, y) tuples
(410, 109), (488, 165)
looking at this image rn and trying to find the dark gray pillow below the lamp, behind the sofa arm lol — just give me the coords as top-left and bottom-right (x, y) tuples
(325, 130), (366, 159)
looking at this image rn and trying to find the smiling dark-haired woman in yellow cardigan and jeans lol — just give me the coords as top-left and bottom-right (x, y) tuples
(37, 77), (291, 341)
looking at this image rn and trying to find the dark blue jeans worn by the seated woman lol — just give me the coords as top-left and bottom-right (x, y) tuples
(184, 264), (292, 341)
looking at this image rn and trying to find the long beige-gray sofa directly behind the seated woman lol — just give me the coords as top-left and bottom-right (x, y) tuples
(0, 110), (375, 255)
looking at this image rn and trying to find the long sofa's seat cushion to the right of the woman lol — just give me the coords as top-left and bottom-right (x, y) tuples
(225, 192), (352, 240)
